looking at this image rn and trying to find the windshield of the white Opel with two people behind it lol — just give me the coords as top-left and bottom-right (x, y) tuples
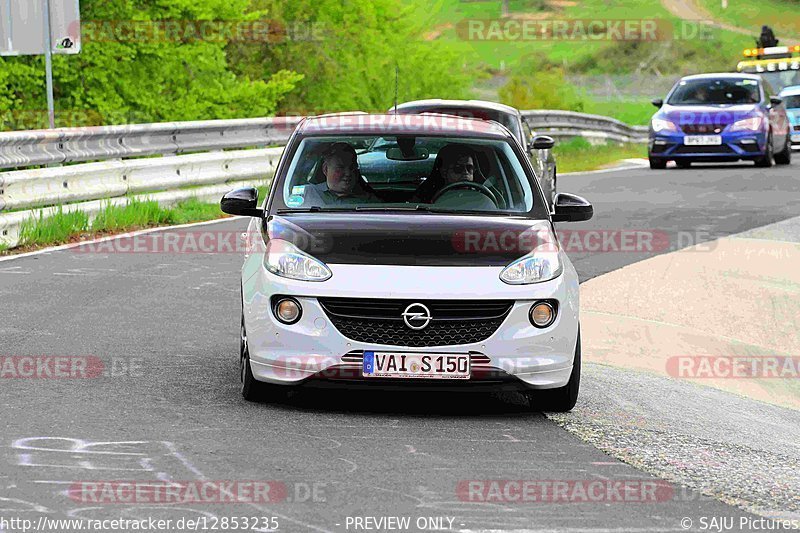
(277, 135), (534, 214)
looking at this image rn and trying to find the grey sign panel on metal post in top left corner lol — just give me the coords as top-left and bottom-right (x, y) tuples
(0, 0), (81, 129)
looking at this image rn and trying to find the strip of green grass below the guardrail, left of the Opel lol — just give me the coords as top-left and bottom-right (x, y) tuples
(7, 198), (228, 253)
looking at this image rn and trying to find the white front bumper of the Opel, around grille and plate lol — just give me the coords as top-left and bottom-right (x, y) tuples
(243, 262), (578, 390)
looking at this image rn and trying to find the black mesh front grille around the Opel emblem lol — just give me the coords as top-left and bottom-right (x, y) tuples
(319, 298), (514, 347)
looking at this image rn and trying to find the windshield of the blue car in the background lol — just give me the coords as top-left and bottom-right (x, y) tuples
(667, 78), (761, 105)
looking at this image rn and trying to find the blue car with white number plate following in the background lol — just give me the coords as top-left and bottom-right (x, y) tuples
(647, 74), (792, 169)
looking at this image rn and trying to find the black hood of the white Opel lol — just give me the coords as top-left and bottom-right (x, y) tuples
(264, 213), (558, 266)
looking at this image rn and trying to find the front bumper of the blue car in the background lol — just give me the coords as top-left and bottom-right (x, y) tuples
(647, 131), (767, 161)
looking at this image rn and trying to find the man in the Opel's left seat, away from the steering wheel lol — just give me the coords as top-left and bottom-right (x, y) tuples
(306, 142), (380, 205)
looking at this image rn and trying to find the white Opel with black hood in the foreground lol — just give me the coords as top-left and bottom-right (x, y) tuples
(221, 114), (593, 411)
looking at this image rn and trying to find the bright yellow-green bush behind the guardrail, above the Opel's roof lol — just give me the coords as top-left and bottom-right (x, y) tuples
(229, 0), (472, 114)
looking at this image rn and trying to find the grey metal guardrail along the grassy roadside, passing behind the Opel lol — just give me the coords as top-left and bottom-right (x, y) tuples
(0, 111), (647, 247)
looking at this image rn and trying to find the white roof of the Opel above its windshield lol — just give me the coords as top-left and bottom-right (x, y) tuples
(297, 112), (513, 139)
